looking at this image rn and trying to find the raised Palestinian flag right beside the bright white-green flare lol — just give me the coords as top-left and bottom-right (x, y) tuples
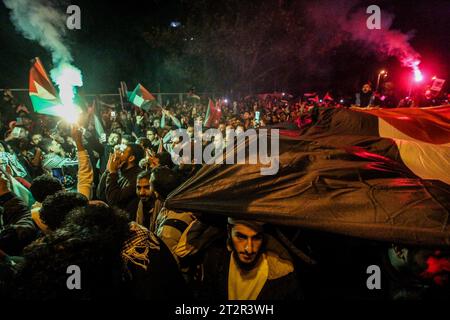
(29, 57), (61, 116)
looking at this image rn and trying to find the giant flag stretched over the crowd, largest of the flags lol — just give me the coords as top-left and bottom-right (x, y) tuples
(166, 106), (450, 246)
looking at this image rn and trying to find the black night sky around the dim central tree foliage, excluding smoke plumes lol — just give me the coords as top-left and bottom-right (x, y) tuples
(0, 0), (450, 93)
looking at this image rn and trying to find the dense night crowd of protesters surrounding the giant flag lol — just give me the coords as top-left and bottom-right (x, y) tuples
(0, 85), (450, 300)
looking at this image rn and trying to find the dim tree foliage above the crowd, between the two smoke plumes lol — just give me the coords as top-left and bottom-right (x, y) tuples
(144, 0), (305, 91)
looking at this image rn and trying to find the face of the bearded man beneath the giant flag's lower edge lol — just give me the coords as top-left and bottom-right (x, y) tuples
(231, 224), (264, 267)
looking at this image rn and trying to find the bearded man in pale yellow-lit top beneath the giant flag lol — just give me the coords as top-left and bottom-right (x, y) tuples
(194, 218), (301, 300)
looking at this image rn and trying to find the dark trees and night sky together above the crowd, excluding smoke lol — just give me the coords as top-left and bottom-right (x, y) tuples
(0, 0), (450, 94)
